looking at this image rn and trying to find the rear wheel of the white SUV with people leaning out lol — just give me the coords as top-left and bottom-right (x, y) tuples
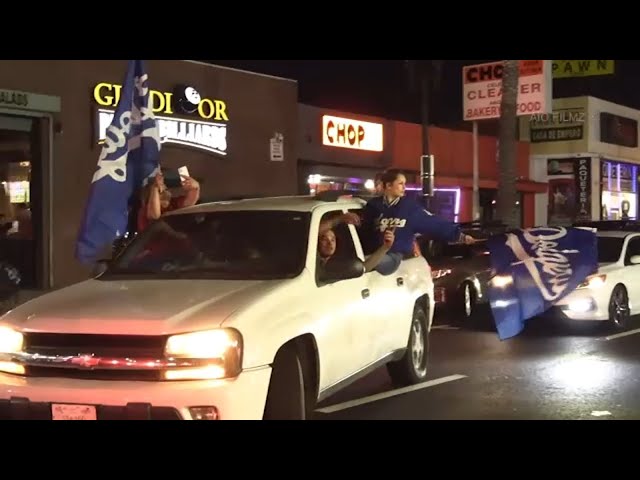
(387, 304), (429, 387)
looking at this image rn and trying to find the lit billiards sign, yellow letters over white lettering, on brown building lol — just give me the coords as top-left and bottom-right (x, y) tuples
(93, 83), (229, 155)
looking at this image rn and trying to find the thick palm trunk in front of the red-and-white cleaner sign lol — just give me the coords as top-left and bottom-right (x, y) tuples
(496, 60), (520, 227)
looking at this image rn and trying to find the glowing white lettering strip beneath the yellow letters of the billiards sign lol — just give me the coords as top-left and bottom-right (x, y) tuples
(98, 110), (227, 155)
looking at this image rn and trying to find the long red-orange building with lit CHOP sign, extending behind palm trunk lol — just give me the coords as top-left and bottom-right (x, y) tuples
(298, 104), (547, 226)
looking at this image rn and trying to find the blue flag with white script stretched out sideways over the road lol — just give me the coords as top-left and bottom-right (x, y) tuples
(487, 227), (598, 340)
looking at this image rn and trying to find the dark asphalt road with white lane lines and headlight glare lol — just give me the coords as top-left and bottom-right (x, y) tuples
(314, 312), (640, 420)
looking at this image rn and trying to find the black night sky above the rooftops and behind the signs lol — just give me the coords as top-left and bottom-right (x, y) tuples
(209, 60), (640, 131)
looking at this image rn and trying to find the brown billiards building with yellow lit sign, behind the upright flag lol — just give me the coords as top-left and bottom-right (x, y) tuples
(0, 60), (298, 289)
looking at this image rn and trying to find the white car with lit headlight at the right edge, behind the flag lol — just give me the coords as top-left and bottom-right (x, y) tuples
(556, 231), (640, 329)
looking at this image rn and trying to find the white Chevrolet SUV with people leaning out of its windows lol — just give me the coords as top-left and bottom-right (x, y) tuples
(0, 197), (433, 420)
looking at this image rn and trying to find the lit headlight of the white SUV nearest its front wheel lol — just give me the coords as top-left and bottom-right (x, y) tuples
(164, 328), (243, 380)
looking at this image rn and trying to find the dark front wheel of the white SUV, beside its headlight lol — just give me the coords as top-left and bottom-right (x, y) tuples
(263, 344), (307, 420)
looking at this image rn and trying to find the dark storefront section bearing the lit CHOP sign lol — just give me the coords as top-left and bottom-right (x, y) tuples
(298, 104), (393, 195)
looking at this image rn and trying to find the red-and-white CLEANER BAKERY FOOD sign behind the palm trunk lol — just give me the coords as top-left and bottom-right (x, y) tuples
(462, 60), (552, 120)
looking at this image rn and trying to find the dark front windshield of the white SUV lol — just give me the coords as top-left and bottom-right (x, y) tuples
(100, 210), (310, 280)
